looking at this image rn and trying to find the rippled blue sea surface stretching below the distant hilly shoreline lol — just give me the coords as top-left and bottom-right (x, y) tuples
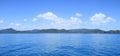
(0, 33), (120, 56)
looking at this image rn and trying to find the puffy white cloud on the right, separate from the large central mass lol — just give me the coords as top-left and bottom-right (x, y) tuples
(90, 13), (115, 24)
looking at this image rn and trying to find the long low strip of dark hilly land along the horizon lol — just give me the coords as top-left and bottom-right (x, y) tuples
(0, 28), (120, 34)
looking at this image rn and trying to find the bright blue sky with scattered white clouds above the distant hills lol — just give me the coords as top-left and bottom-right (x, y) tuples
(0, 0), (120, 30)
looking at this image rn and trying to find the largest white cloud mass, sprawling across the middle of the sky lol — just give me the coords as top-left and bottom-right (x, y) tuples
(37, 12), (82, 29)
